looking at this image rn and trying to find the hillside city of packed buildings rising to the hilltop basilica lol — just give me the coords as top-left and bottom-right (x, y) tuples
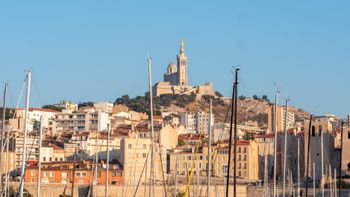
(0, 41), (350, 197)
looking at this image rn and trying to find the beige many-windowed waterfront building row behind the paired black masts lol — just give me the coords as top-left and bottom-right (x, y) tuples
(169, 141), (259, 180)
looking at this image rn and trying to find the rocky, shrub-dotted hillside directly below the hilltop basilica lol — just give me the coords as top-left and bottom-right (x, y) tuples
(115, 94), (309, 128)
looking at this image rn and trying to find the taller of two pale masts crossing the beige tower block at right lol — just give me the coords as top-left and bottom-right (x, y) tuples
(273, 87), (280, 197)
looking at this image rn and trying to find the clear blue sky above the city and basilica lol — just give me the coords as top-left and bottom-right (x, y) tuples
(0, 0), (350, 116)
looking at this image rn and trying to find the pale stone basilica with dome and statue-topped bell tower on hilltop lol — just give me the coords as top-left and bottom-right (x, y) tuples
(153, 41), (215, 96)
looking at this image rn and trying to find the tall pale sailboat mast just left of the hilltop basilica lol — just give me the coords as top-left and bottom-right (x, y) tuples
(147, 58), (156, 197)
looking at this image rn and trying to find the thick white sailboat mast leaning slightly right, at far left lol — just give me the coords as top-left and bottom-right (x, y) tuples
(19, 70), (32, 197)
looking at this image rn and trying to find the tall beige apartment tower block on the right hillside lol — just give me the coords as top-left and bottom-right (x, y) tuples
(267, 106), (295, 133)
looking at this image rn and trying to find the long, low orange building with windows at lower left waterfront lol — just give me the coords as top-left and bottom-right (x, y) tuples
(24, 161), (123, 185)
